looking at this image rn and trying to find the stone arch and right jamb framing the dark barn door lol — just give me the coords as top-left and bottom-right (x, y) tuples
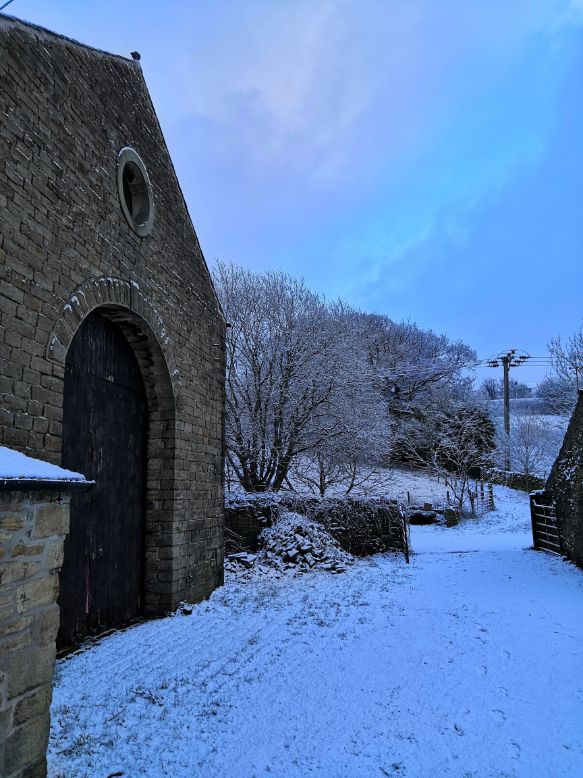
(47, 277), (181, 615)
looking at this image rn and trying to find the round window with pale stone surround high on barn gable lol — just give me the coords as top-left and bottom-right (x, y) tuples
(117, 147), (154, 237)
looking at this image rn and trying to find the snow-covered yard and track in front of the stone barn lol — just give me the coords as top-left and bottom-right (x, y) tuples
(49, 487), (583, 778)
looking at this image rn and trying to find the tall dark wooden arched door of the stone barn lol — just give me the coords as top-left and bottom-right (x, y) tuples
(57, 313), (147, 648)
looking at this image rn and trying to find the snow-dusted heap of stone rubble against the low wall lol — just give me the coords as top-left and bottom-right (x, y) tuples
(225, 512), (353, 573)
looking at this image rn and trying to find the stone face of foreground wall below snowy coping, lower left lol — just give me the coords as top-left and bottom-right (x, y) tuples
(0, 490), (69, 778)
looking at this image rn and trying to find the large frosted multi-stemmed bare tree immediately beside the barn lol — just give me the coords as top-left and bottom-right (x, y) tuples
(215, 263), (338, 491)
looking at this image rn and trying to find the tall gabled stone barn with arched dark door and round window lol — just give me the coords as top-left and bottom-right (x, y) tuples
(0, 15), (225, 647)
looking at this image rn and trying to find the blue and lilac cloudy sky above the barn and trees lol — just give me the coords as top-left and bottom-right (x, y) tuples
(6, 0), (583, 382)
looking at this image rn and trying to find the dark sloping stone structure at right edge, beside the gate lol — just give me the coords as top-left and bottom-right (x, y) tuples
(545, 391), (583, 567)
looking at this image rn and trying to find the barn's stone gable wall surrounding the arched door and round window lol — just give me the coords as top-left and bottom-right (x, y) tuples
(0, 15), (225, 613)
